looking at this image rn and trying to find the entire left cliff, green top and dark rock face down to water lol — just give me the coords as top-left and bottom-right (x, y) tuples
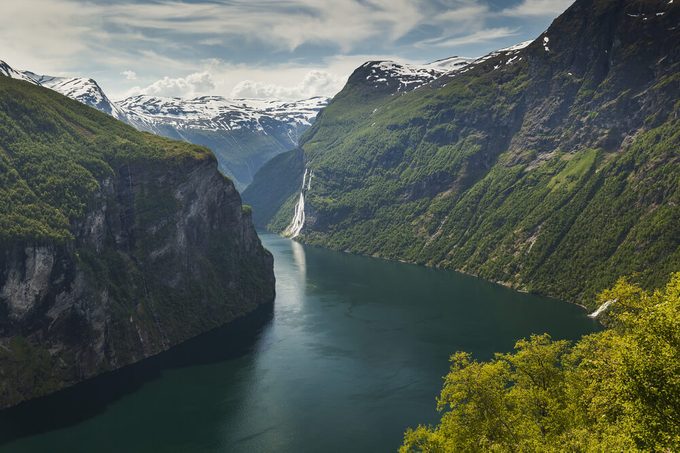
(0, 73), (274, 407)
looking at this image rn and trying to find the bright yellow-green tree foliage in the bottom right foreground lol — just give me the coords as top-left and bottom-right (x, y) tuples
(401, 272), (680, 452)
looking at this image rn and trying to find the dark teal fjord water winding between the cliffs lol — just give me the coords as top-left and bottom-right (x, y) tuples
(0, 234), (598, 452)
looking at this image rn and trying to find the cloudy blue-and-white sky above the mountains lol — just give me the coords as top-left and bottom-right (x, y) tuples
(0, 0), (573, 99)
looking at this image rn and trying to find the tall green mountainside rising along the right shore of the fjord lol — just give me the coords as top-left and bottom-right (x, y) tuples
(244, 0), (680, 304)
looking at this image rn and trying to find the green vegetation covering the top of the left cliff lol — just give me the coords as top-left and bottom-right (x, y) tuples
(0, 77), (210, 242)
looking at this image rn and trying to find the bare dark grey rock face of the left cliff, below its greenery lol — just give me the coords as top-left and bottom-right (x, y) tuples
(0, 75), (274, 407)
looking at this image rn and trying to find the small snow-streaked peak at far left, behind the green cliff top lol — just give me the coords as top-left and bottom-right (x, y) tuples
(0, 60), (125, 121)
